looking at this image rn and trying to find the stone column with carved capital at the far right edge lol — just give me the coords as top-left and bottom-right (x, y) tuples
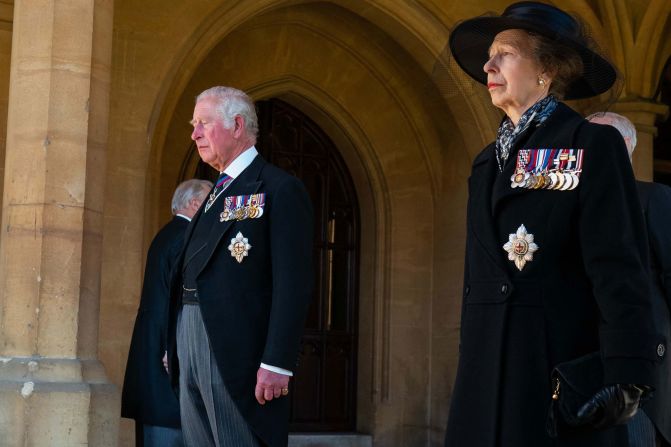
(611, 99), (669, 182)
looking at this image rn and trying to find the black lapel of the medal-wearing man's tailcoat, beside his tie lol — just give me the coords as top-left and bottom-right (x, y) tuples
(198, 155), (266, 275)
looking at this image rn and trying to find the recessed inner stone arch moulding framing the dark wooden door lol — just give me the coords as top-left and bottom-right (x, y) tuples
(144, 4), (476, 445)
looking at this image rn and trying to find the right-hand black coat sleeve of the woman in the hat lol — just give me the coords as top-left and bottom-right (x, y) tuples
(578, 124), (663, 385)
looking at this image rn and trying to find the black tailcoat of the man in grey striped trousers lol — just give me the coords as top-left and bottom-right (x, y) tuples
(169, 155), (314, 447)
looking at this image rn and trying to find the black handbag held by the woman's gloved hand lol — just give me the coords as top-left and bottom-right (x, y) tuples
(545, 352), (604, 438)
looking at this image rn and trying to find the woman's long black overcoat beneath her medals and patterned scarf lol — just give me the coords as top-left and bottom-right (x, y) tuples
(446, 103), (664, 447)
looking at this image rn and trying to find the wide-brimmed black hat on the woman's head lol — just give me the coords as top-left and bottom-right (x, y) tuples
(450, 2), (617, 99)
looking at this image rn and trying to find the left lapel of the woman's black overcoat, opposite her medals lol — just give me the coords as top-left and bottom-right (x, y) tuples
(468, 144), (506, 272)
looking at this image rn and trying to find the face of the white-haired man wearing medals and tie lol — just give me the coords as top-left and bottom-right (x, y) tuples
(191, 98), (239, 171)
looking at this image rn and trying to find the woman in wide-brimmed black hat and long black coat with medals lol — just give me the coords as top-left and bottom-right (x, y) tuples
(446, 2), (666, 447)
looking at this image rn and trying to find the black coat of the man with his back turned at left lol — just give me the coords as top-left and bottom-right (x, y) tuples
(121, 216), (189, 428)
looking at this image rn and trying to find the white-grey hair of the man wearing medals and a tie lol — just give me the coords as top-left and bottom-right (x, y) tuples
(196, 86), (259, 140)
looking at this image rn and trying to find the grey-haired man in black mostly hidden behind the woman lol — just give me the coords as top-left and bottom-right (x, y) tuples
(587, 112), (671, 447)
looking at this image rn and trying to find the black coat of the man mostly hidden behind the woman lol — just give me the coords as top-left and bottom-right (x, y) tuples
(636, 182), (671, 443)
